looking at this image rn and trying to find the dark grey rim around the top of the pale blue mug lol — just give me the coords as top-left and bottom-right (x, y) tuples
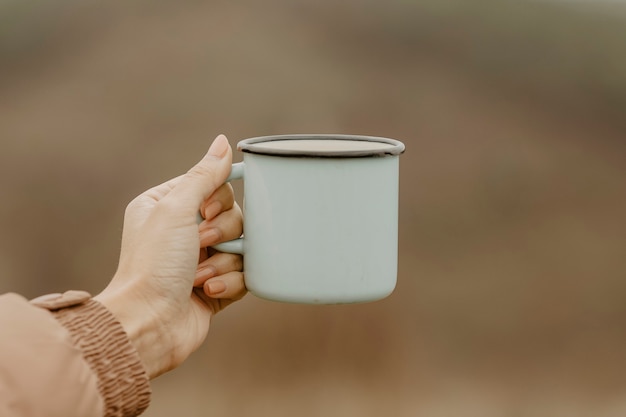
(237, 133), (405, 158)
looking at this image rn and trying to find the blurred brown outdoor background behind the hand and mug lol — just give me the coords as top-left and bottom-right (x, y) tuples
(0, 0), (626, 417)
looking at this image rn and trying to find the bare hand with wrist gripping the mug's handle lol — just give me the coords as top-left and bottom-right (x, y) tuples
(94, 135), (246, 378)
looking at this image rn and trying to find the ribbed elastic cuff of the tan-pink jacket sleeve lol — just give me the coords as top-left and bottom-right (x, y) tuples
(52, 299), (150, 417)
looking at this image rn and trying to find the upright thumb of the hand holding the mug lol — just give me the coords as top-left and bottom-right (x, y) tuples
(163, 135), (233, 215)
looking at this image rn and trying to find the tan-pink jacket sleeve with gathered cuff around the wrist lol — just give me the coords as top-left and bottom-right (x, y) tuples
(0, 291), (150, 417)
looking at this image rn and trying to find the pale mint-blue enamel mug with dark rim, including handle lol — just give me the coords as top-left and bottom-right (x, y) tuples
(213, 135), (405, 304)
